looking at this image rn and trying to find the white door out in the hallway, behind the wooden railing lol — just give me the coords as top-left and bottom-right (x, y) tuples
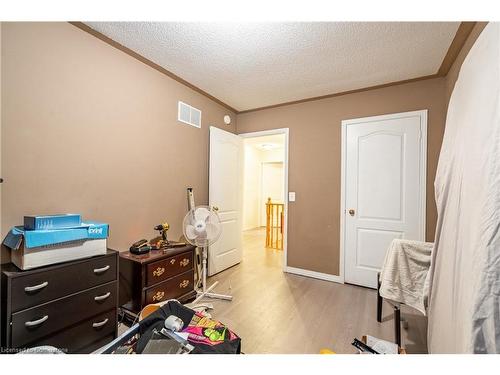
(259, 162), (284, 226)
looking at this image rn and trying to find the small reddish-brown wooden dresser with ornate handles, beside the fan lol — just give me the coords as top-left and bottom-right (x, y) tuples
(120, 245), (196, 315)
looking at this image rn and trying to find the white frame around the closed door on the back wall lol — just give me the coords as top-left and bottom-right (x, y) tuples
(339, 109), (427, 283)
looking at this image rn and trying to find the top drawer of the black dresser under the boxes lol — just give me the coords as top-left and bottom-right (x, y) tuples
(11, 254), (117, 312)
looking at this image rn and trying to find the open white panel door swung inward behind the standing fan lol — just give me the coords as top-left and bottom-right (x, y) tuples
(208, 126), (244, 276)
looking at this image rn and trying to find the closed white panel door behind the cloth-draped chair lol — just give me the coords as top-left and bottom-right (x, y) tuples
(342, 111), (427, 288)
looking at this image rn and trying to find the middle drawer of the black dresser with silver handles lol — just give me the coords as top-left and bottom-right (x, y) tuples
(11, 281), (117, 347)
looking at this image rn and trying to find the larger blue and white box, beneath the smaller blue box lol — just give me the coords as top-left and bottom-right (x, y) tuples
(3, 223), (108, 270)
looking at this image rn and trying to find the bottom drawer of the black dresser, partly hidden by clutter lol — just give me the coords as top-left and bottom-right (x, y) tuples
(27, 309), (116, 353)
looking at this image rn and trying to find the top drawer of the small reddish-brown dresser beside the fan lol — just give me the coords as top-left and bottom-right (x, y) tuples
(146, 251), (193, 286)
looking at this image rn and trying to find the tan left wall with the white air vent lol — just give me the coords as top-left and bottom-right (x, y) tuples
(1, 23), (235, 262)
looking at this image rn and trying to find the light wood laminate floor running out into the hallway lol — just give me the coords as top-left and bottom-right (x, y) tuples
(203, 229), (427, 353)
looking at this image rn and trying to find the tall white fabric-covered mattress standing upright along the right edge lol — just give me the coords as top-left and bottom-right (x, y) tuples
(428, 23), (500, 353)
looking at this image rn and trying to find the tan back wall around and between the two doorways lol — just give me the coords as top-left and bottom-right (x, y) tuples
(237, 78), (445, 275)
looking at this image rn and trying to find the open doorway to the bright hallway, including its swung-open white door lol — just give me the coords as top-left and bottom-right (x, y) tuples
(208, 126), (288, 276)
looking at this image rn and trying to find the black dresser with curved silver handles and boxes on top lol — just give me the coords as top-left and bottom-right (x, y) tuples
(1, 250), (118, 353)
